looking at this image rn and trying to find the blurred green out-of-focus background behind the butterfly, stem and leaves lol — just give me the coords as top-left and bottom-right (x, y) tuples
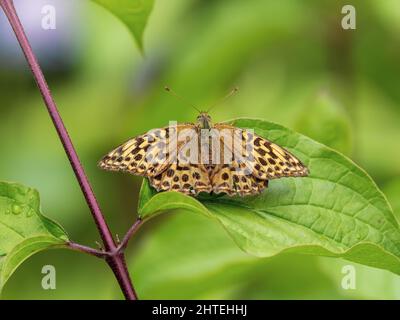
(0, 0), (400, 299)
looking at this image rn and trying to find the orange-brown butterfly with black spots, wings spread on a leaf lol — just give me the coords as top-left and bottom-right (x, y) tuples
(99, 112), (309, 196)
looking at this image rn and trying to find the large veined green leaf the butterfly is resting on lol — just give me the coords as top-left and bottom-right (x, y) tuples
(139, 119), (400, 274)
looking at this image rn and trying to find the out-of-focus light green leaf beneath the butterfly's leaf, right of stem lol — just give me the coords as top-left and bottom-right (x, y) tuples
(128, 212), (258, 299)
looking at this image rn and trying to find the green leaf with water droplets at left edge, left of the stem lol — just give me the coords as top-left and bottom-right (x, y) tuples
(0, 182), (68, 291)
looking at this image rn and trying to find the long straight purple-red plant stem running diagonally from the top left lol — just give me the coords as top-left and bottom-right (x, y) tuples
(0, 0), (137, 300)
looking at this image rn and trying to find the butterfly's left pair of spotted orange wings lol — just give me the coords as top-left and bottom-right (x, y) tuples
(99, 124), (212, 195)
